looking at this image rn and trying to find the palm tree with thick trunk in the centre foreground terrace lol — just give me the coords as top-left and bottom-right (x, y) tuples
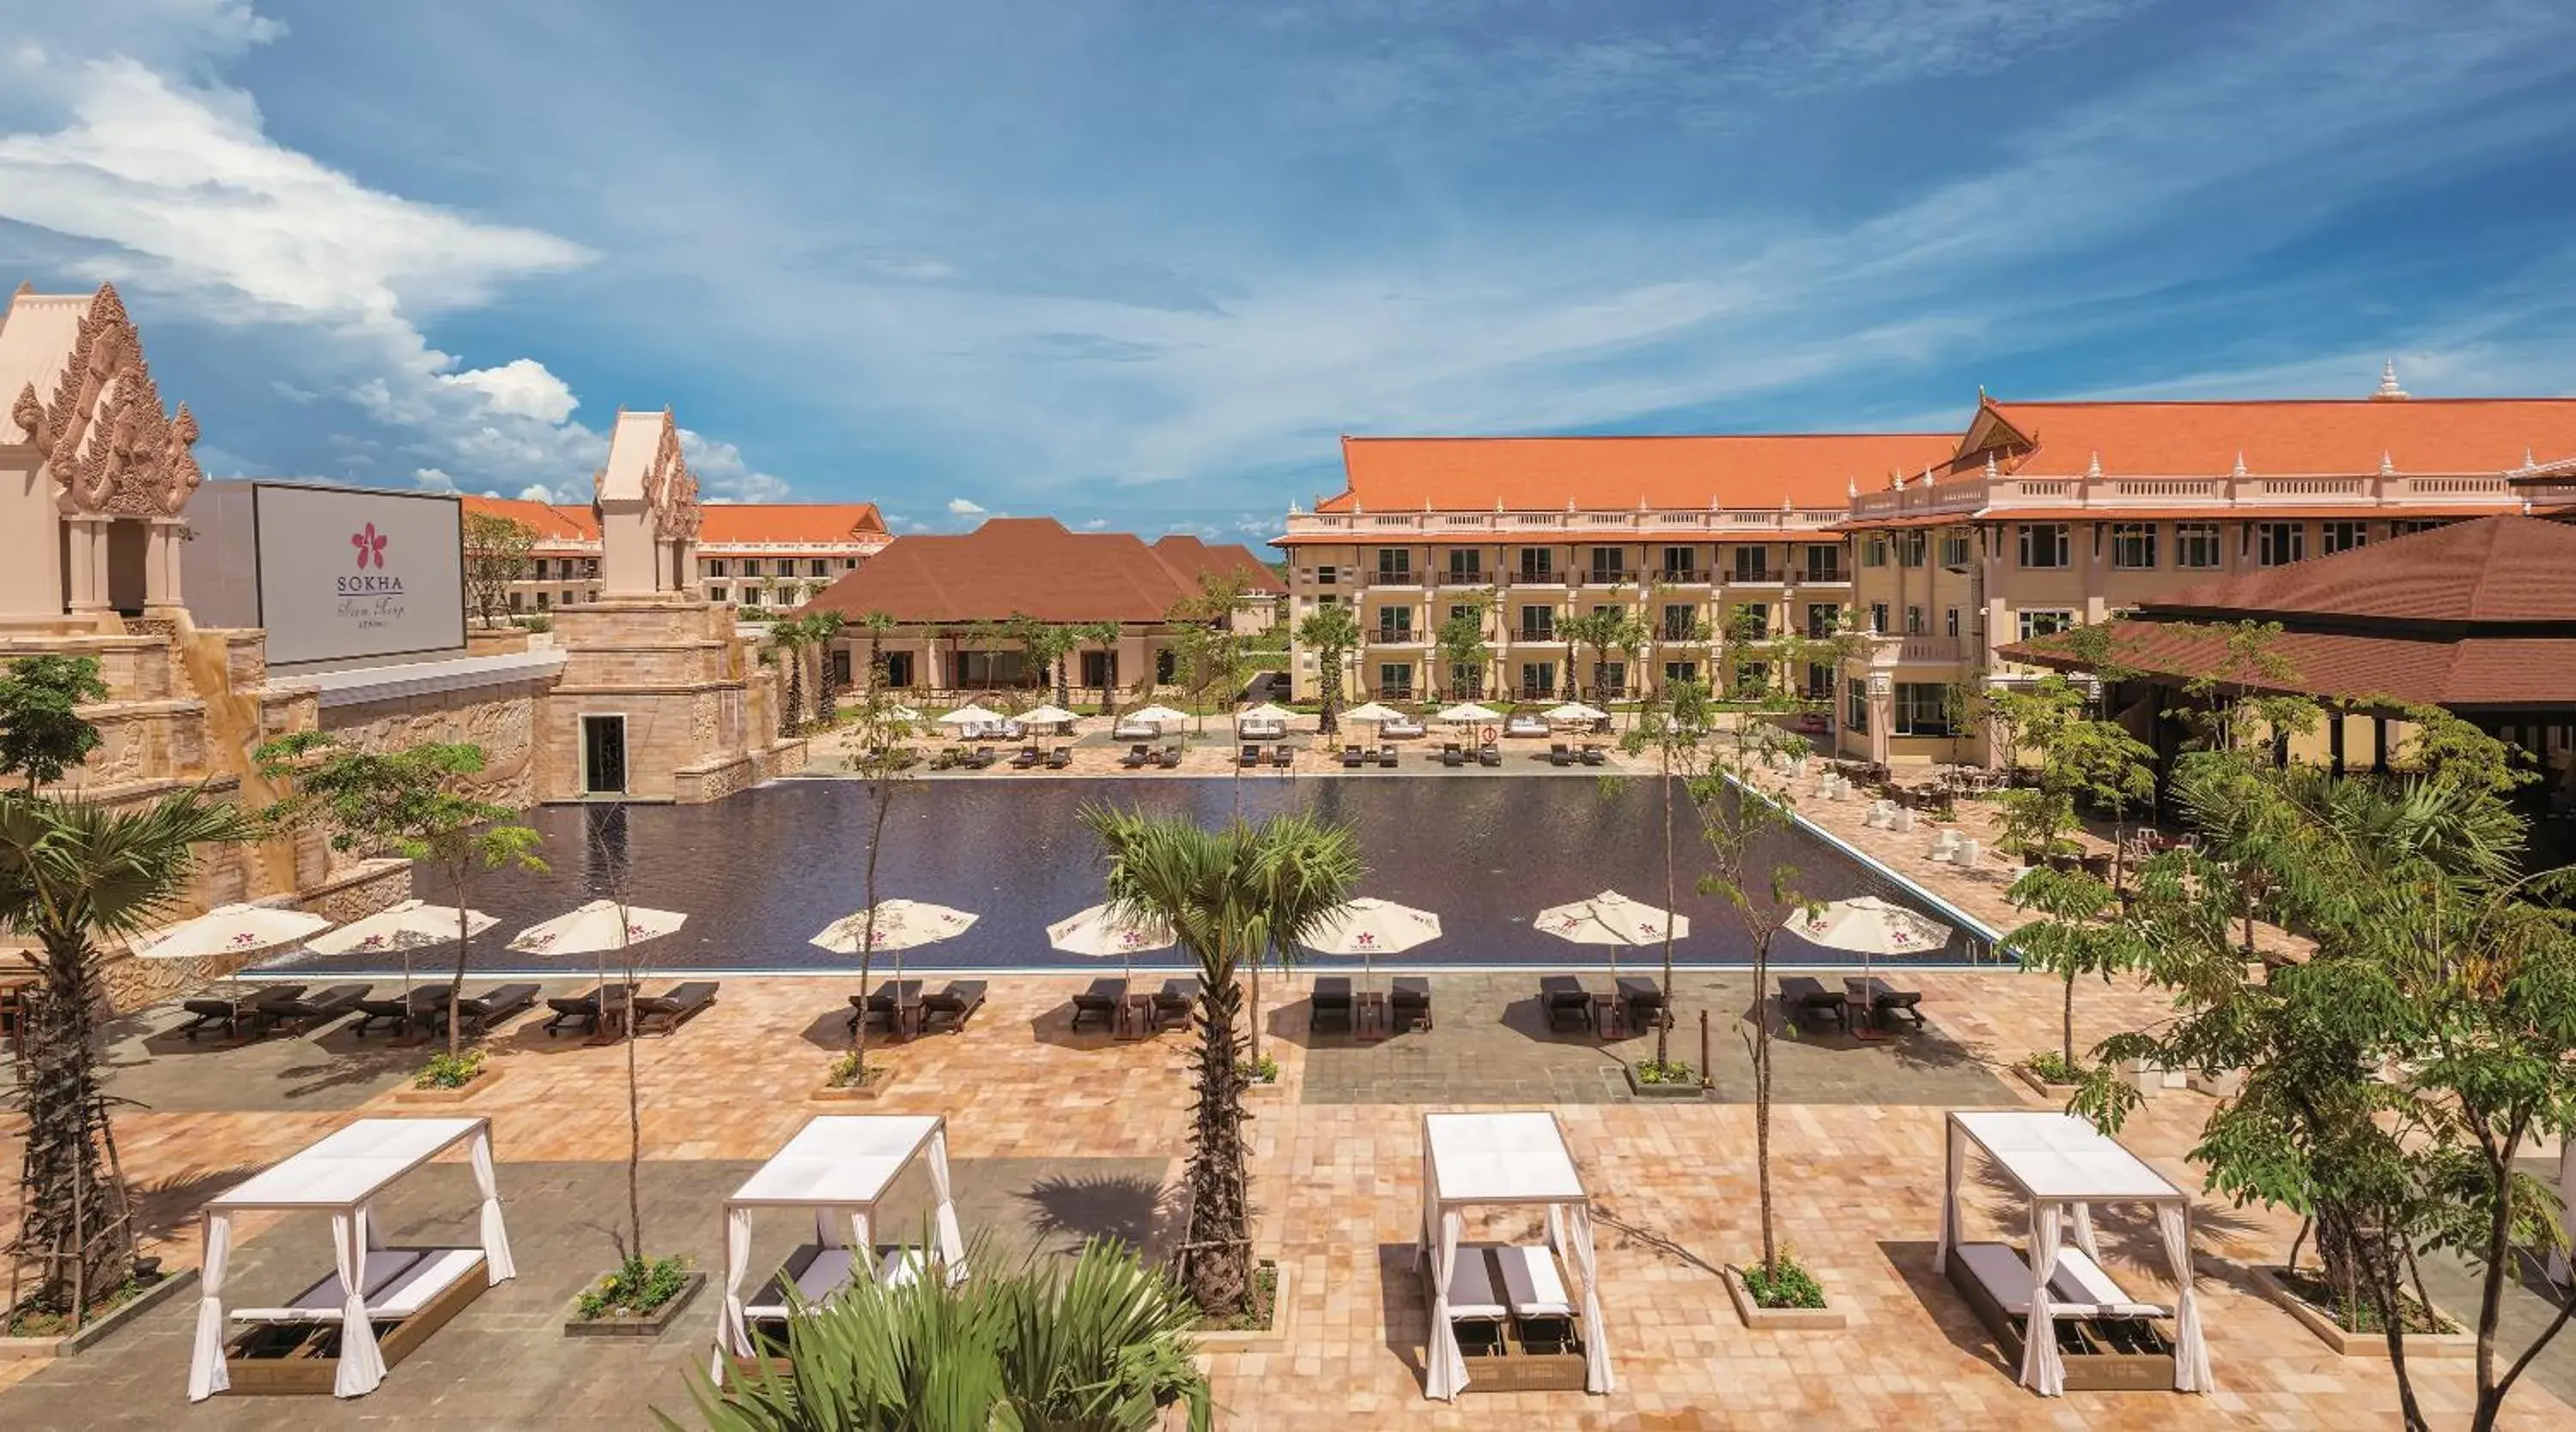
(1082, 806), (1360, 1316)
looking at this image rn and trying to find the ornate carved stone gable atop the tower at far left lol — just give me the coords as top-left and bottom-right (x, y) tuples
(10, 283), (206, 518)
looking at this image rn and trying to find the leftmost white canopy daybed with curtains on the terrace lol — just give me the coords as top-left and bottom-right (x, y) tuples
(188, 1118), (518, 1401)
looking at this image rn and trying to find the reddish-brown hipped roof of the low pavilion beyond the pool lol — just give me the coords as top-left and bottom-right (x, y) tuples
(806, 518), (1278, 623)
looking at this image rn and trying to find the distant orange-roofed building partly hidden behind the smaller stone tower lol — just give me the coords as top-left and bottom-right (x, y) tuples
(466, 497), (894, 613)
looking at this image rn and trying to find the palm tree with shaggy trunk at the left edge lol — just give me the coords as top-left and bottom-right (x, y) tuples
(0, 791), (250, 1324)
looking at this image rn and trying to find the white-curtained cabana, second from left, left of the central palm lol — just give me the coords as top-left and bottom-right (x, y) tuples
(714, 1115), (966, 1375)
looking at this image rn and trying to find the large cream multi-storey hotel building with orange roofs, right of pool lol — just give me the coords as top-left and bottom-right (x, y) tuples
(1278, 371), (2576, 762)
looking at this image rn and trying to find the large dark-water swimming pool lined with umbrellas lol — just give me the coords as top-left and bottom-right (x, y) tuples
(270, 773), (1989, 976)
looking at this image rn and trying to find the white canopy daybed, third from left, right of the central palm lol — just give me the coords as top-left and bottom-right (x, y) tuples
(1422, 1113), (1613, 1401)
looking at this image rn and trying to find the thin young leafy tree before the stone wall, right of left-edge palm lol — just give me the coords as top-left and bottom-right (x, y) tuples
(255, 731), (546, 1059)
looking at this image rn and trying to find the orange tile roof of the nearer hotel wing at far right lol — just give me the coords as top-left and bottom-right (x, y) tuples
(1958, 397), (2576, 476)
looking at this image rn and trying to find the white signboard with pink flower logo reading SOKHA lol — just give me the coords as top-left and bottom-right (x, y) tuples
(255, 482), (466, 664)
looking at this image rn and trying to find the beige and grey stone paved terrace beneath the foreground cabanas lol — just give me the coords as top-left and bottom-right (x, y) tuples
(0, 974), (2576, 1432)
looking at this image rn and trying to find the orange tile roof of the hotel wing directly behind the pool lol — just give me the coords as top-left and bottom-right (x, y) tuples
(1319, 433), (1958, 513)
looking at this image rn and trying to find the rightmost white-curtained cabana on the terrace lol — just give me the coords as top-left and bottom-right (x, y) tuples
(1932, 1113), (2213, 1396)
